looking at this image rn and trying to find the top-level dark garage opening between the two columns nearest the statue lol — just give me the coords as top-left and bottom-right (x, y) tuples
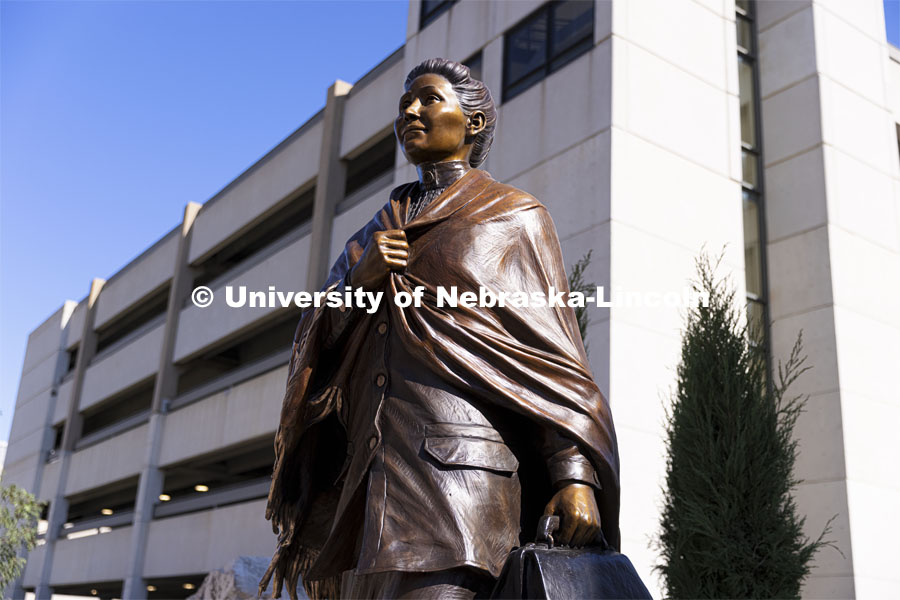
(194, 188), (316, 287)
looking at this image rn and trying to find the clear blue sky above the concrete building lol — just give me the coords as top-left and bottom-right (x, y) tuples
(0, 0), (900, 440)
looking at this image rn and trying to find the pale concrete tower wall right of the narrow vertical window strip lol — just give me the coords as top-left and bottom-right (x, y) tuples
(756, 0), (900, 598)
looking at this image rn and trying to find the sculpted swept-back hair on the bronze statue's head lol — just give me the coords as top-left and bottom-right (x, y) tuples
(404, 58), (497, 167)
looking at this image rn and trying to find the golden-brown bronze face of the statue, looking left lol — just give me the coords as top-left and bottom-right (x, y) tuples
(394, 73), (480, 165)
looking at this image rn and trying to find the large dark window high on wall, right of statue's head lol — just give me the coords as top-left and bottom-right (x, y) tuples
(503, 0), (594, 102)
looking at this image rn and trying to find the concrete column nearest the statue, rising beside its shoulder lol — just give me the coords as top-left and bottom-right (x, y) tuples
(306, 79), (353, 291)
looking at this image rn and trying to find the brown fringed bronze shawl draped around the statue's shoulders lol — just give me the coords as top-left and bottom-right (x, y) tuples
(260, 169), (619, 597)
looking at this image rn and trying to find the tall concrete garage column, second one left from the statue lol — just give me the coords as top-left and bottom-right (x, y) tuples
(122, 202), (200, 600)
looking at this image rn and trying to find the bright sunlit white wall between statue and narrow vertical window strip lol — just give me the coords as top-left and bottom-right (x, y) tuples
(608, 0), (744, 596)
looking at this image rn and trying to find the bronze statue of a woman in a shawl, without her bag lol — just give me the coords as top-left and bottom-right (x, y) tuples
(261, 59), (619, 598)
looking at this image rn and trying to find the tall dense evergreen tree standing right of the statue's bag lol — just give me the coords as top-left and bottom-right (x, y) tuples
(656, 255), (833, 598)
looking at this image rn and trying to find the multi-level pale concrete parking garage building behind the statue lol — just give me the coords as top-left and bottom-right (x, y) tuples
(4, 0), (900, 598)
